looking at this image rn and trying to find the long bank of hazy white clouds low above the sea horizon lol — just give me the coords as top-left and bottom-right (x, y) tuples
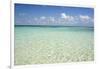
(17, 13), (94, 25)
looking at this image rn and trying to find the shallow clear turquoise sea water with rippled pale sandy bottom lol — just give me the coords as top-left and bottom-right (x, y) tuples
(14, 26), (94, 65)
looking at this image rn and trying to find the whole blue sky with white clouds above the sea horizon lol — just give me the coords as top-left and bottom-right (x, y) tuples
(14, 4), (94, 27)
